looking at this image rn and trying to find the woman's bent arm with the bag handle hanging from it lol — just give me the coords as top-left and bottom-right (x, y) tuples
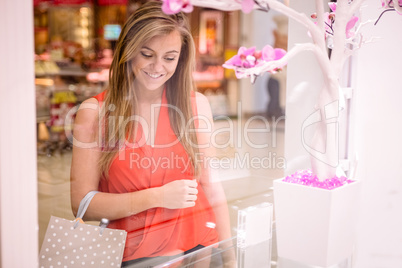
(70, 98), (196, 220)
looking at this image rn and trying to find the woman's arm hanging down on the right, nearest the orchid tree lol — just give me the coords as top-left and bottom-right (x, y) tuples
(196, 93), (236, 267)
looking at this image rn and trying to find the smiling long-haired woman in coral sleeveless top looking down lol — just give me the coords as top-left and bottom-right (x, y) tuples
(71, 2), (233, 265)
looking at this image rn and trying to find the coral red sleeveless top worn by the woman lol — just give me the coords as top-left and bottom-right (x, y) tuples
(95, 89), (218, 261)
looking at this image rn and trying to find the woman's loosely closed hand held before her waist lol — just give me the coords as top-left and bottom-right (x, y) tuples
(161, 180), (198, 209)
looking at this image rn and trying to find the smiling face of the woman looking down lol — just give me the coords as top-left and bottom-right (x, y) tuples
(131, 31), (182, 94)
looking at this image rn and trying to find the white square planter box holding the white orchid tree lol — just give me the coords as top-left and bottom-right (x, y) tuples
(274, 179), (361, 267)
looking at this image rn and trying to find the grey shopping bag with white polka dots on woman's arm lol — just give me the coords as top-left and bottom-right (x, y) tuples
(39, 191), (127, 268)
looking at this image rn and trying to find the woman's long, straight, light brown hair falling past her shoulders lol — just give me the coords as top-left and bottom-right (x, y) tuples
(99, 1), (200, 178)
